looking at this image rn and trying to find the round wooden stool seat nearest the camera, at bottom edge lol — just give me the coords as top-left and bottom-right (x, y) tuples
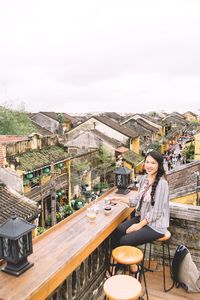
(103, 275), (142, 300)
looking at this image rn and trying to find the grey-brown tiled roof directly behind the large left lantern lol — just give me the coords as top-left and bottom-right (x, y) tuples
(0, 183), (40, 224)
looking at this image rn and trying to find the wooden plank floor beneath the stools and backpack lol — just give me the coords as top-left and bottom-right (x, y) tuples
(144, 266), (200, 300)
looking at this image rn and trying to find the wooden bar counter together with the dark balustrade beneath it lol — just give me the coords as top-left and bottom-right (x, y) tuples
(0, 190), (133, 300)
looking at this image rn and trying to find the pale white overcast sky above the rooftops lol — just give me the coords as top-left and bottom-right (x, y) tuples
(0, 0), (200, 113)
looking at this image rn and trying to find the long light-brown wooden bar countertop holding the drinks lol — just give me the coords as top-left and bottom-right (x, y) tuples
(0, 189), (135, 300)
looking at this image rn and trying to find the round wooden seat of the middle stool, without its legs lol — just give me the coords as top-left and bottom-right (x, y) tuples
(112, 246), (143, 265)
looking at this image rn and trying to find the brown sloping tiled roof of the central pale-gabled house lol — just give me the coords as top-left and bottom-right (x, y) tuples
(93, 116), (138, 138)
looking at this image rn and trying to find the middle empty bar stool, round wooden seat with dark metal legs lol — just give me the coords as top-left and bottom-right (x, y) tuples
(112, 246), (149, 300)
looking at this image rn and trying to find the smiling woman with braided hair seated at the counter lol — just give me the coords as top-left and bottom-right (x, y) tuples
(112, 150), (169, 247)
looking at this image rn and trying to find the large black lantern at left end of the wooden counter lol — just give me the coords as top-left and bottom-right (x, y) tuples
(0, 215), (35, 276)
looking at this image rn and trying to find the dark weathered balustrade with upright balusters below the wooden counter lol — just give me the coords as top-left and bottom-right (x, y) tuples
(47, 238), (111, 300)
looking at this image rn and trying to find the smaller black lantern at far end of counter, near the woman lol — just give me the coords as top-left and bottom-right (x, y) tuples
(114, 167), (132, 195)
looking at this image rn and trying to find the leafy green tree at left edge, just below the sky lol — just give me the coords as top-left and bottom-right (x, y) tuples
(0, 106), (35, 135)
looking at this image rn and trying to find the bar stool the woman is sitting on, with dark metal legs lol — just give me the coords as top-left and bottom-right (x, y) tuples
(144, 230), (172, 292)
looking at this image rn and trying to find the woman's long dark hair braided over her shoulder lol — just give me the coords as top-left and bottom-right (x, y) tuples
(145, 150), (166, 206)
